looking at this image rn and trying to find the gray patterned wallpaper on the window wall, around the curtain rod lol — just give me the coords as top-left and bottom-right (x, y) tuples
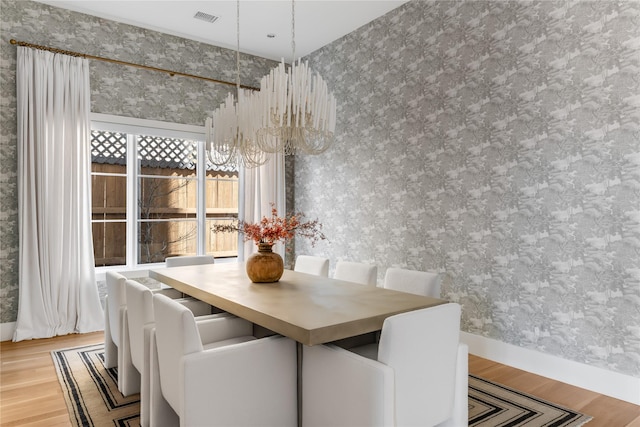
(0, 0), (276, 323)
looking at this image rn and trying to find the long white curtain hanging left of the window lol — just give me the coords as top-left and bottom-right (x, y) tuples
(13, 47), (104, 341)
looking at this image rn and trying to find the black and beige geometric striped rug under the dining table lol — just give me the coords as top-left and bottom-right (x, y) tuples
(51, 344), (591, 427)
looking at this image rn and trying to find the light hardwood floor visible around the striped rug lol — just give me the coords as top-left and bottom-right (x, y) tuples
(0, 332), (640, 427)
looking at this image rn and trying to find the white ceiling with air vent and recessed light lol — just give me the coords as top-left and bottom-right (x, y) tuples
(32, 0), (407, 62)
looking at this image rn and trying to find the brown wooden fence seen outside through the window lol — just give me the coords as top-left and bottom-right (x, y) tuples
(92, 163), (238, 266)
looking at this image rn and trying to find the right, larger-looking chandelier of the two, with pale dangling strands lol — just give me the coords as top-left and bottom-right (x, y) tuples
(256, 0), (336, 155)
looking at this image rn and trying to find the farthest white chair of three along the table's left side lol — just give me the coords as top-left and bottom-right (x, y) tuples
(104, 271), (182, 396)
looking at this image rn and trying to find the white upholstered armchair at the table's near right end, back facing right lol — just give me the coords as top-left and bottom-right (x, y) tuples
(302, 304), (468, 427)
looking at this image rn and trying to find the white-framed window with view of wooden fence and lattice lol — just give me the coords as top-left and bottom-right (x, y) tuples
(91, 115), (238, 267)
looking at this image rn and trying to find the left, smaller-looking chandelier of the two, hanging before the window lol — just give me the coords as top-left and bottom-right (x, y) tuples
(205, 0), (267, 168)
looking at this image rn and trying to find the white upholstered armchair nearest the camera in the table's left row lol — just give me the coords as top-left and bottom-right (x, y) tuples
(151, 295), (297, 427)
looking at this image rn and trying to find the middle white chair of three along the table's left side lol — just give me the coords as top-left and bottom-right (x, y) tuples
(126, 280), (230, 427)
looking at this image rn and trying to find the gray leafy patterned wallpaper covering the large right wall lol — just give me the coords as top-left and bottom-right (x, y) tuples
(295, 1), (640, 376)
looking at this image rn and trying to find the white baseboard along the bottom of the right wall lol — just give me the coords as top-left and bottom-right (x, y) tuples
(460, 332), (640, 405)
